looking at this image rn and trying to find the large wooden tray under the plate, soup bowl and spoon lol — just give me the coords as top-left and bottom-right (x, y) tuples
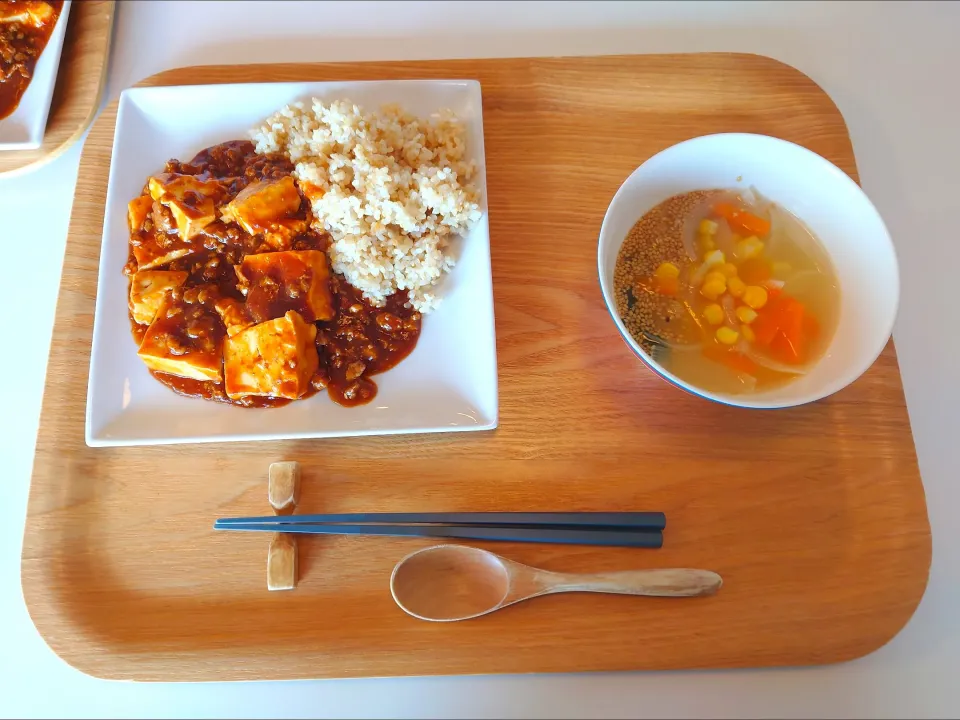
(22, 54), (930, 680)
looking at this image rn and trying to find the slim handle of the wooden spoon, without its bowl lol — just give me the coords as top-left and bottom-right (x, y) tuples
(544, 568), (723, 597)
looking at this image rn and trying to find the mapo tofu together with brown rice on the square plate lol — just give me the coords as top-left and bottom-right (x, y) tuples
(124, 101), (480, 407)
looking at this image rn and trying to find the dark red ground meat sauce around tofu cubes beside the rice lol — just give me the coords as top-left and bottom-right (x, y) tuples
(124, 140), (421, 407)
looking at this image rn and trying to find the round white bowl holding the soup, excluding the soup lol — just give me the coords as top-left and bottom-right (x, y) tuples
(597, 133), (900, 408)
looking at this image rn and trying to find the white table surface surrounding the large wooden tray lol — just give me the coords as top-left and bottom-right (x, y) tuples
(0, 2), (960, 717)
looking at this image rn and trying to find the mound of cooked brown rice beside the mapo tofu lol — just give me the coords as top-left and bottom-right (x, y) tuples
(251, 98), (480, 312)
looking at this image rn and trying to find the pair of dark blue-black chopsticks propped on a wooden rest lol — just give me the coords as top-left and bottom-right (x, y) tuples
(213, 512), (667, 548)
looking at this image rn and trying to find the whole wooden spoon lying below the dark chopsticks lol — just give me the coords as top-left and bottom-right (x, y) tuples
(390, 545), (723, 622)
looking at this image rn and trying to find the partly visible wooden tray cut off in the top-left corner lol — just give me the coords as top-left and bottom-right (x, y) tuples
(0, 0), (116, 176)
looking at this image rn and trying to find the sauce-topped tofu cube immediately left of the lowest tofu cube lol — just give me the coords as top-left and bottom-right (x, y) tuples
(137, 299), (223, 382)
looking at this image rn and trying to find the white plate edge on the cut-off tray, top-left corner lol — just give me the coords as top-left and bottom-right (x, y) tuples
(0, 0), (70, 150)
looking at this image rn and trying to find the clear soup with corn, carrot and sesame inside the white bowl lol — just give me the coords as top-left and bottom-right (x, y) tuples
(614, 189), (840, 394)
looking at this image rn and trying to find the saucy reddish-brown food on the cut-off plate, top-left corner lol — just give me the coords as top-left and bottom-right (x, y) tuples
(0, 0), (63, 119)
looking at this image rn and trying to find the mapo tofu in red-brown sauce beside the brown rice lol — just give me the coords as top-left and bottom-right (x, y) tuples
(124, 141), (420, 407)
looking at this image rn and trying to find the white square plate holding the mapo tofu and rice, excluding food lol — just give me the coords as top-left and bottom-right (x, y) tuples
(86, 80), (497, 446)
